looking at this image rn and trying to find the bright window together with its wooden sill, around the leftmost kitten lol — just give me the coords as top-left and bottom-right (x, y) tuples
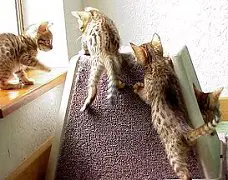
(0, 0), (68, 118)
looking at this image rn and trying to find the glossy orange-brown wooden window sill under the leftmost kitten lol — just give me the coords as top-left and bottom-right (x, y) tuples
(0, 68), (66, 118)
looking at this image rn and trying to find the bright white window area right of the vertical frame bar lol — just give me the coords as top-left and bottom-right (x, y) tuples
(22, 0), (68, 67)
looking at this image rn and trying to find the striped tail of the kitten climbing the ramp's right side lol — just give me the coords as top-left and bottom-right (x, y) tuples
(187, 116), (220, 142)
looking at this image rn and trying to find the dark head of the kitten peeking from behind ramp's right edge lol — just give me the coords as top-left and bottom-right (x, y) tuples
(194, 87), (223, 122)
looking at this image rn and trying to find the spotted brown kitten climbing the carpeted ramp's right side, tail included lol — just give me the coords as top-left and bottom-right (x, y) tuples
(131, 34), (222, 180)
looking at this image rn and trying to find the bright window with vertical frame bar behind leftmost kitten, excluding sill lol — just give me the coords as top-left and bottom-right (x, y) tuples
(0, 0), (68, 67)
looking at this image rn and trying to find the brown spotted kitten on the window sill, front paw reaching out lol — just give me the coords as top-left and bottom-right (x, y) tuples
(0, 22), (52, 89)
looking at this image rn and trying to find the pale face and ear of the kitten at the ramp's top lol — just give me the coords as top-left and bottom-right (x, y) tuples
(71, 11), (91, 32)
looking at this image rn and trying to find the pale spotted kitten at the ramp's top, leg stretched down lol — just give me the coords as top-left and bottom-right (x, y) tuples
(72, 7), (125, 111)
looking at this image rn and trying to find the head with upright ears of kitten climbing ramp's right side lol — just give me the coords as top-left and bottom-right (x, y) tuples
(130, 33), (163, 66)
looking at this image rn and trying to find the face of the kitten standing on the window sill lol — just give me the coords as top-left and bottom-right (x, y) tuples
(36, 23), (53, 51)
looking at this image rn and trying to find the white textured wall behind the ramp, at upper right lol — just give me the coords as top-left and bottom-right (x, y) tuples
(84, 0), (228, 96)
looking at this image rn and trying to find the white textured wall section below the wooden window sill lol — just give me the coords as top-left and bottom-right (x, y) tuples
(0, 85), (63, 179)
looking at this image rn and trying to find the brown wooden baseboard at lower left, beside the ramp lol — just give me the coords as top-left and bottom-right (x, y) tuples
(6, 137), (53, 180)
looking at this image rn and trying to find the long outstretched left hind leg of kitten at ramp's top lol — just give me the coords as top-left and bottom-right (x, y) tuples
(80, 63), (104, 111)
